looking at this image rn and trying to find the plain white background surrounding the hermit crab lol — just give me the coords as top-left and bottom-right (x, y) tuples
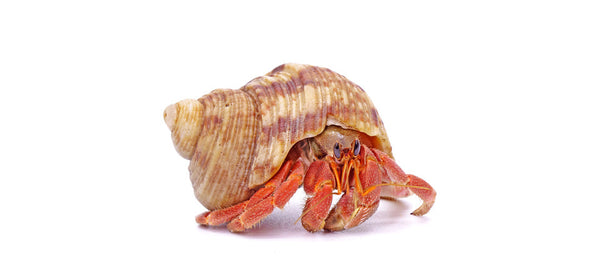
(0, 1), (600, 263)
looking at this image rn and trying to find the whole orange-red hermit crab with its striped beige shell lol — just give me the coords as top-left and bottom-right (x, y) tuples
(163, 64), (436, 232)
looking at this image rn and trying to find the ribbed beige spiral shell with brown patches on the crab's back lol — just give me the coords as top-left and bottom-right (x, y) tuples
(164, 64), (391, 210)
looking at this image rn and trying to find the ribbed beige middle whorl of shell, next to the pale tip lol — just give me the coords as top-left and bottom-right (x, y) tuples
(189, 89), (260, 209)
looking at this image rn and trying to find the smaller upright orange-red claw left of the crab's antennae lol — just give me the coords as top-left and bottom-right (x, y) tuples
(302, 160), (335, 232)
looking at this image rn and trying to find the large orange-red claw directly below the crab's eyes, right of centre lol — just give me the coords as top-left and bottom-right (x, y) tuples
(324, 150), (381, 231)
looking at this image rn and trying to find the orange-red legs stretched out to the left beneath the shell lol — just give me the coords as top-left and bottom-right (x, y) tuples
(196, 161), (304, 232)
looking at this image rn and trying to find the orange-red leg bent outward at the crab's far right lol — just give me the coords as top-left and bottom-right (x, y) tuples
(373, 150), (436, 216)
